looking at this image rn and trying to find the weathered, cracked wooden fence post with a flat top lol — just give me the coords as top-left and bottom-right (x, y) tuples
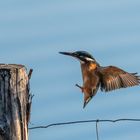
(0, 64), (31, 140)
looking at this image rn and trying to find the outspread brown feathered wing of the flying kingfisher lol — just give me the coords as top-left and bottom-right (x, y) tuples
(99, 66), (140, 92)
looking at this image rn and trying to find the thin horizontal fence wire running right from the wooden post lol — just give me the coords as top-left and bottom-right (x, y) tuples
(29, 119), (140, 130)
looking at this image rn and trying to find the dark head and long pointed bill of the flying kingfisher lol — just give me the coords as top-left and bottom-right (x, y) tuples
(59, 51), (96, 63)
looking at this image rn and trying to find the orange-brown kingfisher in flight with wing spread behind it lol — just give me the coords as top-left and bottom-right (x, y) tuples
(59, 51), (140, 108)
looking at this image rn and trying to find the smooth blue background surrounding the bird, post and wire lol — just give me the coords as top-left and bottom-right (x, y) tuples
(0, 0), (140, 140)
